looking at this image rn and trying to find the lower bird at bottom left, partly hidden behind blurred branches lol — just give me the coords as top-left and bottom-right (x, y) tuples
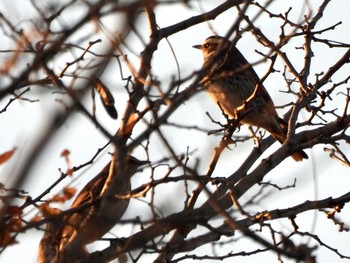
(51, 156), (149, 262)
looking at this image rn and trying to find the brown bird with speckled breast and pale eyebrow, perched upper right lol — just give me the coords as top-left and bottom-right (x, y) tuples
(193, 35), (308, 161)
